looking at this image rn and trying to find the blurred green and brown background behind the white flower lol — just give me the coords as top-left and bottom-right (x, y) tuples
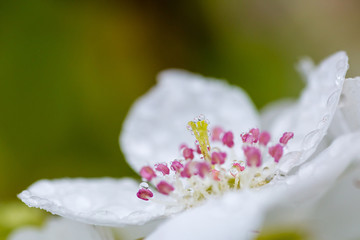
(0, 0), (360, 236)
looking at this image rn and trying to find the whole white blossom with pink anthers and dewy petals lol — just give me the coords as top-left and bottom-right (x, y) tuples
(11, 52), (360, 239)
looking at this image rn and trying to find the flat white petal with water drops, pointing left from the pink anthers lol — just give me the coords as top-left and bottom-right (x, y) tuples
(19, 178), (181, 227)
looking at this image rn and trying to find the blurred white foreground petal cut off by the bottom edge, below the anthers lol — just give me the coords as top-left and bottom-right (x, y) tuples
(147, 191), (268, 240)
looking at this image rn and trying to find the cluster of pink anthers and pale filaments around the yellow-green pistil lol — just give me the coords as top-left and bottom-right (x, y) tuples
(137, 115), (294, 207)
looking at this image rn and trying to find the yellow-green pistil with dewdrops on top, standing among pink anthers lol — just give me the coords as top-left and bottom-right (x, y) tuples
(188, 117), (210, 160)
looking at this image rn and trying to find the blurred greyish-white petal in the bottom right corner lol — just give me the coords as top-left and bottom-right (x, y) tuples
(309, 160), (360, 240)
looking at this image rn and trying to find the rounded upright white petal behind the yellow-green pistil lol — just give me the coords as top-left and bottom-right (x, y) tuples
(120, 70), (258, 171)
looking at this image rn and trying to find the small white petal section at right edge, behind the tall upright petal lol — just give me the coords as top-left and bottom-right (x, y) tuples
(330, 77), (360, 136)
